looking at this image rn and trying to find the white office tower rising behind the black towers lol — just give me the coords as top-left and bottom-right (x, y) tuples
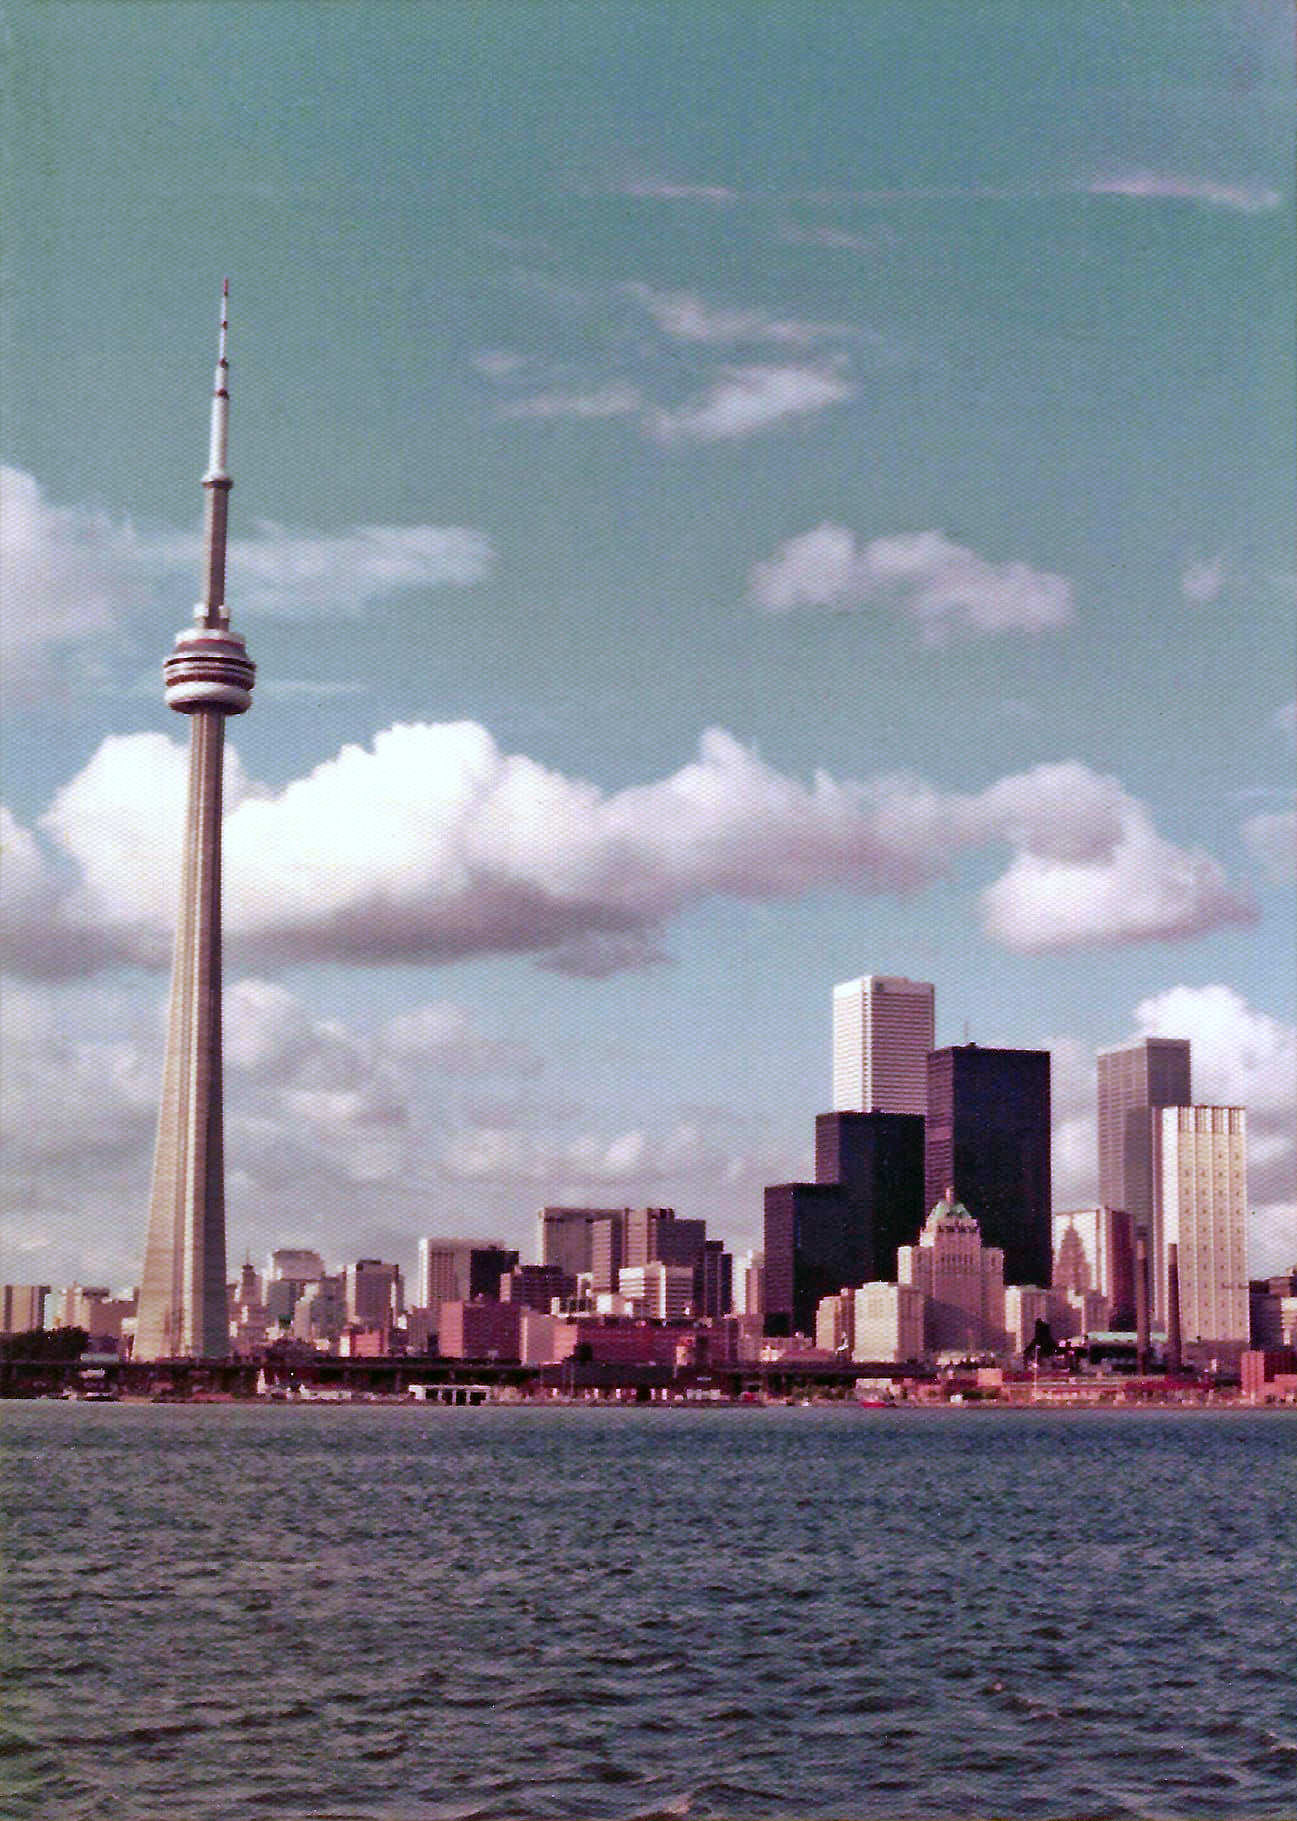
(832, 974), (934, 1116)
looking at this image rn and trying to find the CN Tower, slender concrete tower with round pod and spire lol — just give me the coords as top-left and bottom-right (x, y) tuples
(135, 280), (255, 1360)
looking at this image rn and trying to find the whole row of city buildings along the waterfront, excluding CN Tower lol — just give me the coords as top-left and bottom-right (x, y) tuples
(0, 974), (1297, 1391)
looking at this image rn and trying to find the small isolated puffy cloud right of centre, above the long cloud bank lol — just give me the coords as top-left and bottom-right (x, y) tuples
(749, 523), (1071, 645)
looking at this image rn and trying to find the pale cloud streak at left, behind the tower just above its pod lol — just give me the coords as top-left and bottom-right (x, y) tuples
(0, 468), (492, 688)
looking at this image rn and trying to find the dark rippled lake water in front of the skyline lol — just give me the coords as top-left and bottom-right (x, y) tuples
(0, 1404), (1297, 1821)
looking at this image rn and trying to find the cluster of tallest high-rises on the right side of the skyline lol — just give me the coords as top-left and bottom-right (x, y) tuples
(763, 974), (1260, 1364)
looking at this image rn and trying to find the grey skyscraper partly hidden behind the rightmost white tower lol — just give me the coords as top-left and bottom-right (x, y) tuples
(1098, 1036), (1193, 1233)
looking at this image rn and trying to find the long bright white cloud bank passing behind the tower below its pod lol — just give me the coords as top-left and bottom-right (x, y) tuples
(0, 723), (1253, 976)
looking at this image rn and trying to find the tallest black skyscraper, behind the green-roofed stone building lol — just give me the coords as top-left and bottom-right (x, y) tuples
(924, 1043), (1053, 1287)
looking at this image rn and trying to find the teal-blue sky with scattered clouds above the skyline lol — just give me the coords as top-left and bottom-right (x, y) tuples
(0, 0), (1297, 1287)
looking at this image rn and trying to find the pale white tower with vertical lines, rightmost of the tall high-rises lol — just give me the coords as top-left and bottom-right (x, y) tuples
(1149, 1107), (1248, 1344)
